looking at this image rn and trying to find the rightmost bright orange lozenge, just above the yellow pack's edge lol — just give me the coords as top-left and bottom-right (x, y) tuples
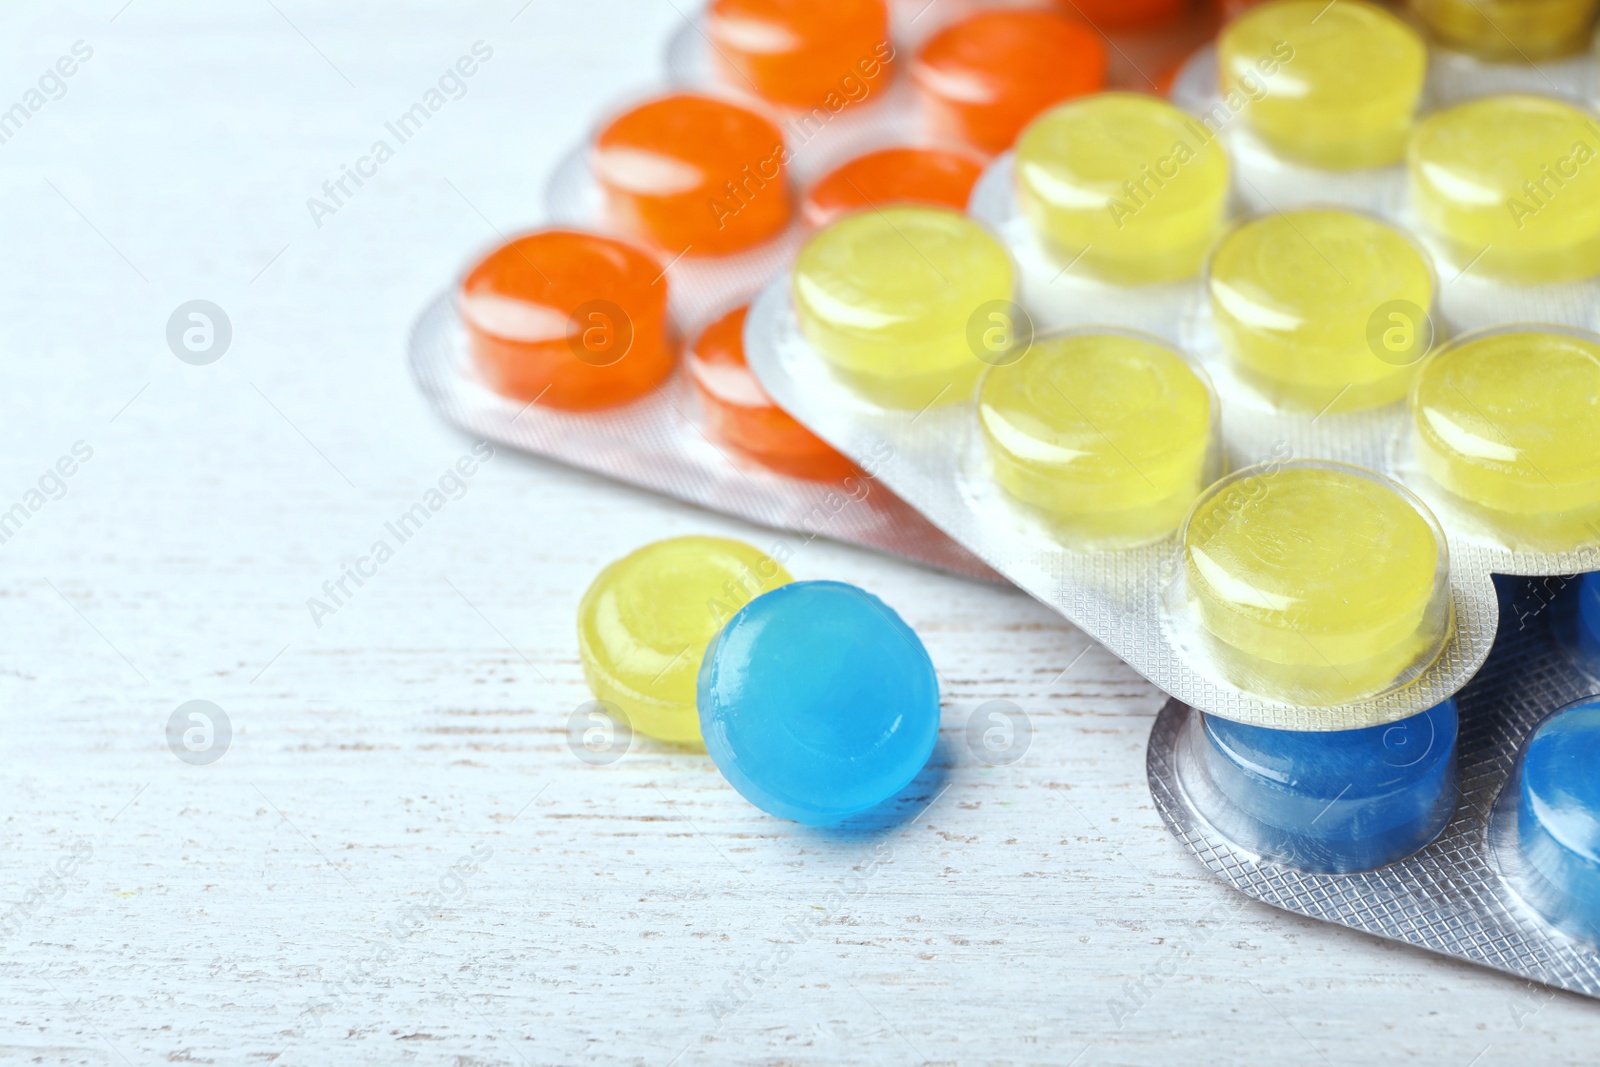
(910, 10), (1106, 152)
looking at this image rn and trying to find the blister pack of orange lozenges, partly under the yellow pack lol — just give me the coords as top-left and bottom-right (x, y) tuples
(411, 0), (1235, 579)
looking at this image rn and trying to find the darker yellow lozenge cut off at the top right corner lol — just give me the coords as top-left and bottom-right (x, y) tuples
(1411, 0), (1600, 62)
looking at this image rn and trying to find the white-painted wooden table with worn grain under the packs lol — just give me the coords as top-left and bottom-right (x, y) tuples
(0, 0), (1600, 1067)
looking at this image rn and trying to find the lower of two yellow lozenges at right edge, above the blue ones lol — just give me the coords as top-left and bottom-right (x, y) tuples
(1411, 326), (1600, 550)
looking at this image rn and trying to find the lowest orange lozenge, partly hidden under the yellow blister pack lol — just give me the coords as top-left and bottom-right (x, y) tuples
(685, 307), (856, 482)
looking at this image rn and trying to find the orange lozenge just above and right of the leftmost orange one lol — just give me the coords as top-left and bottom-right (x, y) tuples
(594, 93), (790, 256)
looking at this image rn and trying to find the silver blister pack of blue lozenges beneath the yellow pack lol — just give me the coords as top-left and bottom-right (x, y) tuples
(1147, 575), (1600, 997)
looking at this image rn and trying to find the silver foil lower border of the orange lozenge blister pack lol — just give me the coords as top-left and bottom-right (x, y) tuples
(408, 290), (1005, 582)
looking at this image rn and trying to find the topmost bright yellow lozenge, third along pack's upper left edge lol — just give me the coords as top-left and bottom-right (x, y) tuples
(1218, 0), (1427, 170)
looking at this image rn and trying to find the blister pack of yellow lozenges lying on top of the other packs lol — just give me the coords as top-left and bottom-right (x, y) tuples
(746, 0), (1600, 731)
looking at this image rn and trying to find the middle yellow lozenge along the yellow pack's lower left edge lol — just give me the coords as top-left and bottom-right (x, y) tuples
(978, 333), (1213, 547)
